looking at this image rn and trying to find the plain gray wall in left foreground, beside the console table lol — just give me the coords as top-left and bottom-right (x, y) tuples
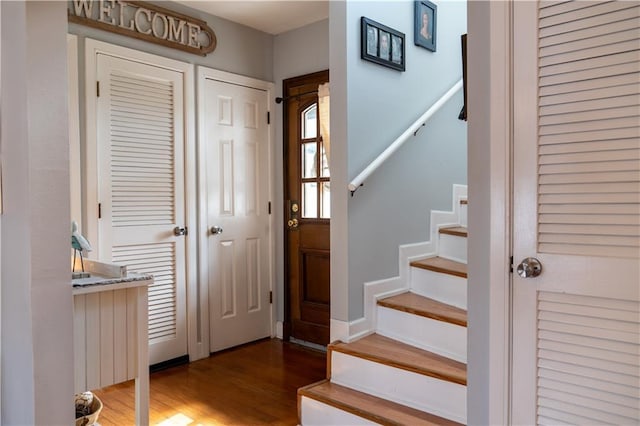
(0, 2), (73, 425)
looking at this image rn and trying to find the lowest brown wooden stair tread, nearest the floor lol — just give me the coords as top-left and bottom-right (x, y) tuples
(298, 380), (460, 426)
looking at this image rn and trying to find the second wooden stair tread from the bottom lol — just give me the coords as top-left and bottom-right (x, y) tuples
(327, 334), (467, 386)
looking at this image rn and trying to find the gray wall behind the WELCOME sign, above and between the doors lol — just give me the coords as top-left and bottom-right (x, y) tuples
(69, 2), (329, 328)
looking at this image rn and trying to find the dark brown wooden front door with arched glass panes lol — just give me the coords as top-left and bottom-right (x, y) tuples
(283, 71), (331, 345)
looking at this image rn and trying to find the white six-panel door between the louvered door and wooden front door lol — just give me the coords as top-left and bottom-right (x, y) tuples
(201, 79), (271, 352)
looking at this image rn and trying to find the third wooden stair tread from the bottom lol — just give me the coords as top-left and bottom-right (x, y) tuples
(378, 292), (467, 327)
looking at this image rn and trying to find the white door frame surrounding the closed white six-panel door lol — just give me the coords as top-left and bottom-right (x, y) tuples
(195, 66), (277, 359)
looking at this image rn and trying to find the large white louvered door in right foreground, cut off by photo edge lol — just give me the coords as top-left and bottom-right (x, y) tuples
(511, 1), (640, 425)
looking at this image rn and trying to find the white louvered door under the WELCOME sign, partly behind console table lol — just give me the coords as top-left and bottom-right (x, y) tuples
(97, 54), (187, 364)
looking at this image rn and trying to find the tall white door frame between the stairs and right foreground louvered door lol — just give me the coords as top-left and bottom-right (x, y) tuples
(467, 1), (513, 424)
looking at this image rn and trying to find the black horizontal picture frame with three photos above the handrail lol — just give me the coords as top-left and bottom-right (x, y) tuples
(360, 16), (405, 71)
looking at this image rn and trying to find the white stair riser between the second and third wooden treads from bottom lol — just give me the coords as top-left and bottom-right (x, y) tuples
(376, 306), (467, 363)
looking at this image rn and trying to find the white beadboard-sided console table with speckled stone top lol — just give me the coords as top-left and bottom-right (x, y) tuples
(72, 273), (153, 425)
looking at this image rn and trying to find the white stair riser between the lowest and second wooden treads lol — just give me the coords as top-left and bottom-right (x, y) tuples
(331, 351), (467, 424)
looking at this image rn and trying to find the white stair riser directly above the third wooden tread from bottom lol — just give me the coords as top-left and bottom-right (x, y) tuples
(411, 268), (467, 309)
